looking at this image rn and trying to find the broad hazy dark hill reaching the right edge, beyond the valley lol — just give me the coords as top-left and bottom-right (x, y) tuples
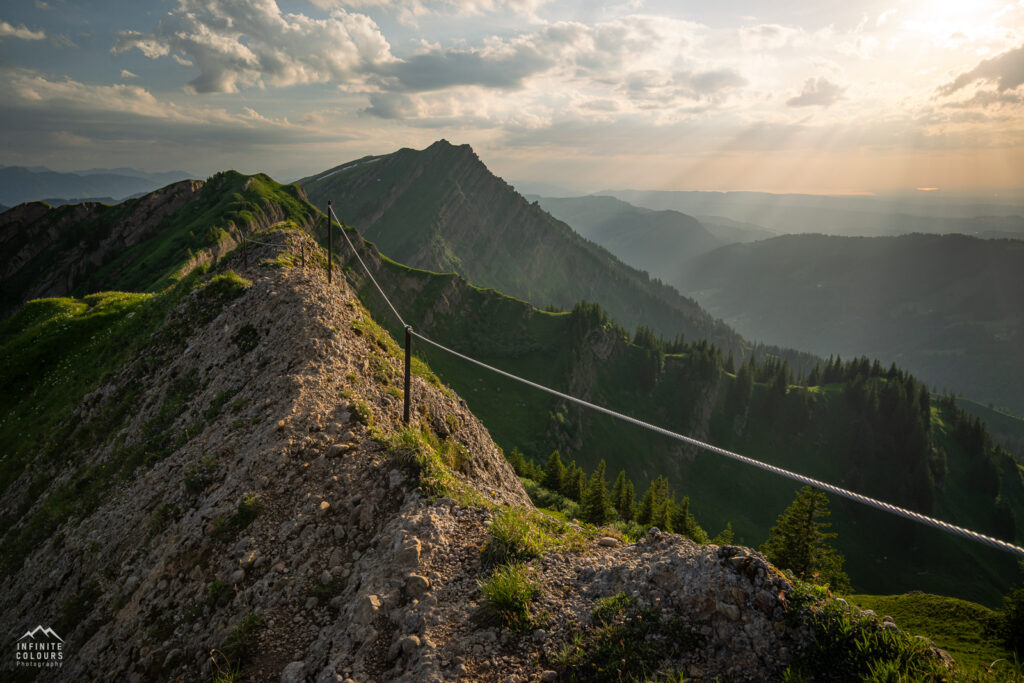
(681, 234), (1024, 413)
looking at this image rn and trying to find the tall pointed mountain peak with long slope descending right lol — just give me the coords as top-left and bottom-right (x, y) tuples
(299, 140), (742, 352)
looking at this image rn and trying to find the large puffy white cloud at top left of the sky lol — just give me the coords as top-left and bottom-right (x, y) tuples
(113, 0), (395, 93)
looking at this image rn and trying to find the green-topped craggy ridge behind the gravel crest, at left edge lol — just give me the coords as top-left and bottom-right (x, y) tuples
(0, 171), (316, 314)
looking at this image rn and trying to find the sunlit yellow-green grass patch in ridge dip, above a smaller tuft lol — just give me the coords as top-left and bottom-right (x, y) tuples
(482, 508), (587, 564)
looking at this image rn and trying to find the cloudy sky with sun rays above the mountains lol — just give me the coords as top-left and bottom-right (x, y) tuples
(0, 0), (1024, 196)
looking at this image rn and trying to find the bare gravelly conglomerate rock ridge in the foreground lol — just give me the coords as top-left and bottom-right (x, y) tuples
(0, 230), (929, 682)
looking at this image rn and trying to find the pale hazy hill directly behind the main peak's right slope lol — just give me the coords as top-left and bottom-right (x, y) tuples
(527, 196), (727, 283)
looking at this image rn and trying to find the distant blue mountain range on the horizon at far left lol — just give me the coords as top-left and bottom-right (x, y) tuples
(0, 166), (196, 206)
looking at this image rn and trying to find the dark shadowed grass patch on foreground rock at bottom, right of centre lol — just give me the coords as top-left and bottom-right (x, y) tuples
(556, 593), (702, 682)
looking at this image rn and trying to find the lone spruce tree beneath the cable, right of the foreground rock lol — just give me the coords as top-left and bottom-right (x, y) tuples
(761, 486), (850, 591)
